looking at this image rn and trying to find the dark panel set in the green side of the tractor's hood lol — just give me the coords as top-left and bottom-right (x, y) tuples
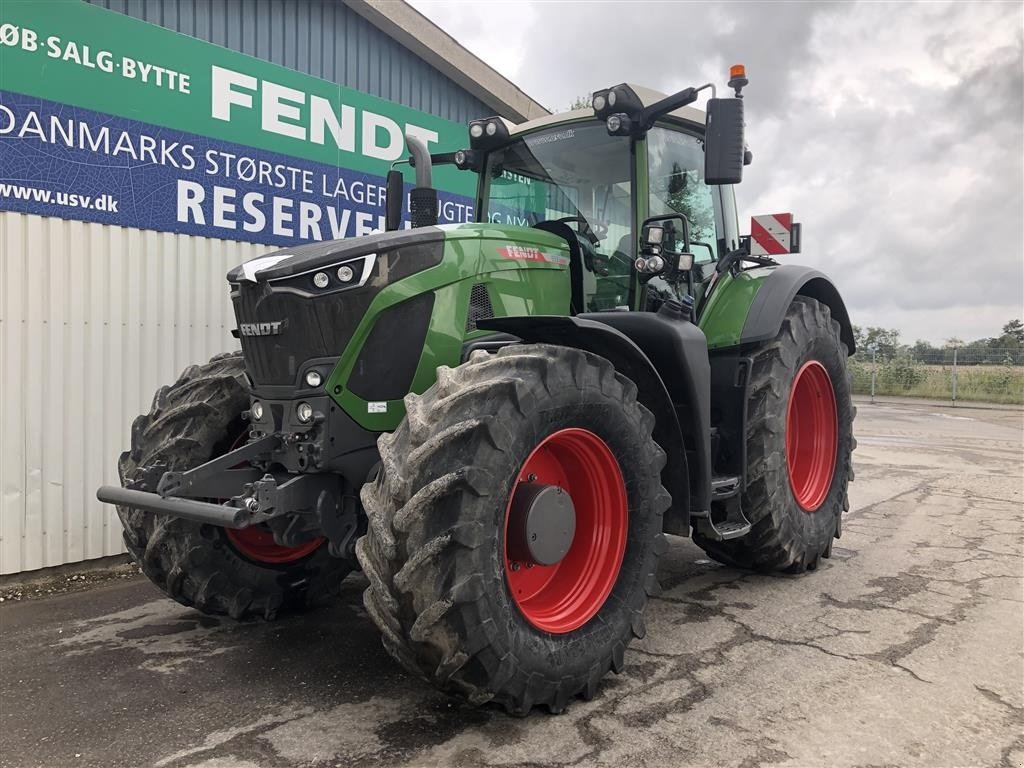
(347, 293), (434, 400)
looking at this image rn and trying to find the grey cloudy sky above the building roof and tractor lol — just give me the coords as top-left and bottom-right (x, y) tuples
(412, 0), (1024, 343)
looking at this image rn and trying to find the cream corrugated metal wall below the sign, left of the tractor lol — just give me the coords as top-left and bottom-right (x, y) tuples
(0, 212), (264, 573)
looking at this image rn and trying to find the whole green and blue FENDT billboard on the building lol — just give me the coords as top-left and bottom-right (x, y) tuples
(0, 0), (475, 245)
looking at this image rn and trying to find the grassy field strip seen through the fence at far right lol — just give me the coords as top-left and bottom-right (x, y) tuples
(850, 358), (1024, 404)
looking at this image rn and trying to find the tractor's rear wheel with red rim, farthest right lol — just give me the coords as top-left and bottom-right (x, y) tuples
(694, 296), (856, 573)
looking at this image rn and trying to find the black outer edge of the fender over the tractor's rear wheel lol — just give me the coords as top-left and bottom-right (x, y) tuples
(739, 264), (856, 354)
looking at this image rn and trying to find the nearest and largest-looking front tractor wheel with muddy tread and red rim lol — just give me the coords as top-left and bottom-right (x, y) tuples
(356, 345), (670, 715)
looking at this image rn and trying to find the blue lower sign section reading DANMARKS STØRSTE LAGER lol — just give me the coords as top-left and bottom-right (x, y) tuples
(0, 91), (473, 246)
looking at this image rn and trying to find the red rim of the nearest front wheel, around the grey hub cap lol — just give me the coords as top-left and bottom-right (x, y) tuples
(503, 428), (629, 635)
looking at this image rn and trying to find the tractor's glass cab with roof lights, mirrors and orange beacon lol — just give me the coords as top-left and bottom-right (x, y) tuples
(394, 68), (751, 314)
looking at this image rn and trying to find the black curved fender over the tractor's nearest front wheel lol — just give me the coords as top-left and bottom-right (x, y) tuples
(477, 312), (696, 536)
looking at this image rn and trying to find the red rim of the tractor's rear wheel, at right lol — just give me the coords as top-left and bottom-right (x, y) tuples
(785, 360), (839, 512)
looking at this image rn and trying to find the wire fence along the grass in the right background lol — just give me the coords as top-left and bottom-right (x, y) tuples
(850, 346), (1024, 404)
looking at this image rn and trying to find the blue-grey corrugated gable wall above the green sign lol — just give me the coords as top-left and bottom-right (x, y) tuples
(86, 0), (495, 123)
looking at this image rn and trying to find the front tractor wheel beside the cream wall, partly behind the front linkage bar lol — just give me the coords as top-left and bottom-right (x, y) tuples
(118, 353), (350, 620)
